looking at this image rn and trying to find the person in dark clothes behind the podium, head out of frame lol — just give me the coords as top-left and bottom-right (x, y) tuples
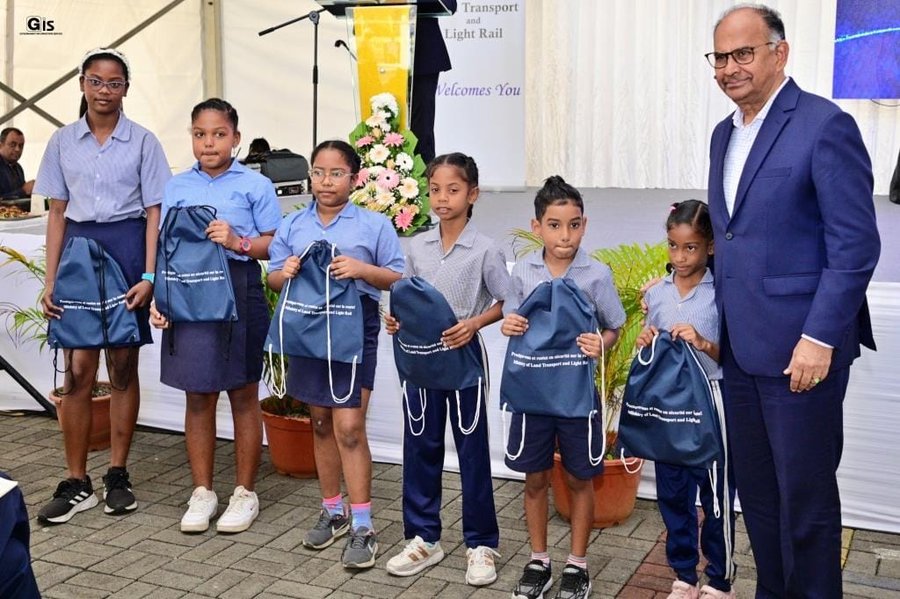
(409, 0), (456, 164)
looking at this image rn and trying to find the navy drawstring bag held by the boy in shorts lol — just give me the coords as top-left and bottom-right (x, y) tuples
(500, 278), (605, 465)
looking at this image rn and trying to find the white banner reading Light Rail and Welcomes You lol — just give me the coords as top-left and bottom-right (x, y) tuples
(434, 0), (525, 188)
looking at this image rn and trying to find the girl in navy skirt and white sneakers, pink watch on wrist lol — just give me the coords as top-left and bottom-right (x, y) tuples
(150, 98), (281, 533)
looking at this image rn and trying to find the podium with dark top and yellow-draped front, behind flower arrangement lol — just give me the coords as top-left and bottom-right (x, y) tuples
(319, 0), (451, 130)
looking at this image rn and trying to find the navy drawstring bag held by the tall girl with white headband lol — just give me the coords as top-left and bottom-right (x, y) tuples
(47, 237), (141, 349)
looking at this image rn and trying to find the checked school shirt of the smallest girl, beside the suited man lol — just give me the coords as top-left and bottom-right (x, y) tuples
(644, 268), (722, 380)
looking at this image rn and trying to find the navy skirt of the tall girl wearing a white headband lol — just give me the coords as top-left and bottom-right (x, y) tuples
(62, 218), (153, 347)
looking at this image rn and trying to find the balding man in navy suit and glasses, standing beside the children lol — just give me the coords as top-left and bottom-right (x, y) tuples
(707, 5), (880, 598)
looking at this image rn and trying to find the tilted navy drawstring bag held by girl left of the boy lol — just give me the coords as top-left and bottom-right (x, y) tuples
(390, 277), (489, 436)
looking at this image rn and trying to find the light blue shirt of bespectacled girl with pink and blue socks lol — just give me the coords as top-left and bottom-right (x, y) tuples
(269, 201), (405, 301)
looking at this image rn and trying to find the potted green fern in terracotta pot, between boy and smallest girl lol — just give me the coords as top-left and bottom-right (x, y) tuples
(512, 229), (668, 528)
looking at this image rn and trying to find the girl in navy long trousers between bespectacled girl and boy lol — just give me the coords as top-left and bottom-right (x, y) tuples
(385, 153), (509, 586)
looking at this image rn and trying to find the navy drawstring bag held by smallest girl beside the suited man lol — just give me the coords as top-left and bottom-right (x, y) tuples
(618, 331), (724, 468)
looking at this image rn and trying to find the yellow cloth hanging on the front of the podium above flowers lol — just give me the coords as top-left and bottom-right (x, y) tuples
(348, 5), (414, 130)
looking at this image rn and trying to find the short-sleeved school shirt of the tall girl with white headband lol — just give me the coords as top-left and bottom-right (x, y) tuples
(34, 112), (172, 223)
